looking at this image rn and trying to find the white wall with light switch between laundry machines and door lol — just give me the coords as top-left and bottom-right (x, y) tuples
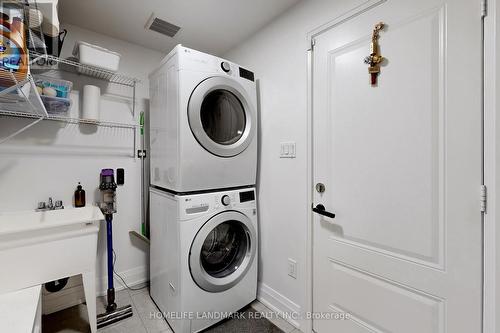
(224, 0), (372, 330)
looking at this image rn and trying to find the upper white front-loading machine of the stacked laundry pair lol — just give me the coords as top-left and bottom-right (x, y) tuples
(149, 45), (258, 193)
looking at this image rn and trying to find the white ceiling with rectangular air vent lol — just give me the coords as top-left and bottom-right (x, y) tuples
(59, 0), (301, 55)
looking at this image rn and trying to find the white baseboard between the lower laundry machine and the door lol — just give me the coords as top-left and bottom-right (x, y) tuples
(257, 282), (301, 329)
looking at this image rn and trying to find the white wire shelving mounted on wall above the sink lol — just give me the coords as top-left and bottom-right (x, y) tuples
(0, 0), (140, 154)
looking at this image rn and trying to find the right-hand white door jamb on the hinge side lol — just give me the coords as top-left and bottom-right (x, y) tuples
(483, 0), (500, 333)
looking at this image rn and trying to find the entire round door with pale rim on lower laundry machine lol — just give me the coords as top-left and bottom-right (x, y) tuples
(189, 211), (257, 292)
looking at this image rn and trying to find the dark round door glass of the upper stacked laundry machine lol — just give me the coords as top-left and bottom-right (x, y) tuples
(200, 89), (246, 145)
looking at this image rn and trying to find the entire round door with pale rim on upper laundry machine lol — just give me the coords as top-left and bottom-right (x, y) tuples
(188, 76), (257, 157)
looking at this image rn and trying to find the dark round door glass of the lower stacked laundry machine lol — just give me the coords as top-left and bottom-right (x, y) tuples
(200, 221), (249, 278)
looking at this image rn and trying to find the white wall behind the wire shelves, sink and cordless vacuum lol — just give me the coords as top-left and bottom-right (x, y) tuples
(0, 25), (163, 292)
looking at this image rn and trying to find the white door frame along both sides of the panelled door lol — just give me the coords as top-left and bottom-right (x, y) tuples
(301, 0), (492, 333)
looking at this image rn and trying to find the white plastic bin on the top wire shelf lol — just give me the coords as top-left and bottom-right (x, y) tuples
(73, 41), (121, 72)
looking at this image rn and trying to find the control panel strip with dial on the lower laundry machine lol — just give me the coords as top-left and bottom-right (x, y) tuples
(178, 188), (257, 219)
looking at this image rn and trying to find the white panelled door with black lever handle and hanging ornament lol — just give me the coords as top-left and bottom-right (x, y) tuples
(313, 0), (482, 333)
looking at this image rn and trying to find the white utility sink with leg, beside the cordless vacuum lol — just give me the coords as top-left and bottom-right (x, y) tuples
(0, 206), (104, 332)
